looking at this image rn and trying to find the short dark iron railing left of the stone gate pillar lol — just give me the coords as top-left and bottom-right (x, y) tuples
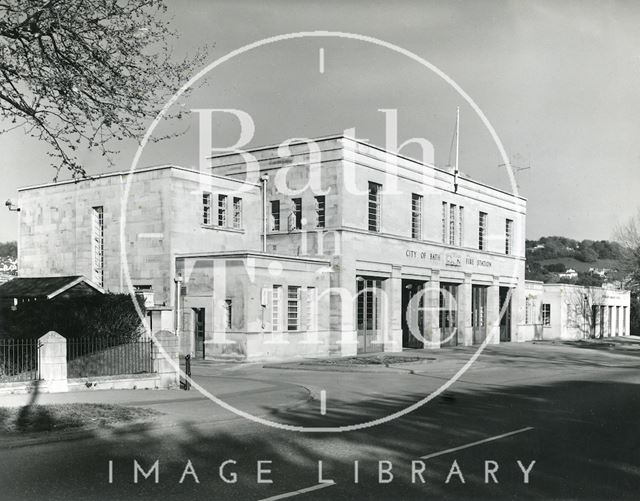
(0, 338), (39, 383)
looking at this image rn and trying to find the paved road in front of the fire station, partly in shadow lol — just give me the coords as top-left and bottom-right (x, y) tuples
(0, 344), (640, 500)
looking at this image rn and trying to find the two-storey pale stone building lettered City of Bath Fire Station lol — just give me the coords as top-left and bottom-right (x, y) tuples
(18, 135), (628, 360)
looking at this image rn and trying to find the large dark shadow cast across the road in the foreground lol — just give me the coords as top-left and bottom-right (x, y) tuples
(0, 376), (640, 499)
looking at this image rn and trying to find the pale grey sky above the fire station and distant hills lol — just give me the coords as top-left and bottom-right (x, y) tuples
(0, 0), (640, 242)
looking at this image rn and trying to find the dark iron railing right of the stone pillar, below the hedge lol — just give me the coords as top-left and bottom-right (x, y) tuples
(67, 336), (153, 378)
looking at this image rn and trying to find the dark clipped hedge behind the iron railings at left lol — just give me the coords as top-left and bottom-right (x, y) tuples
(0, 294), (145, 340)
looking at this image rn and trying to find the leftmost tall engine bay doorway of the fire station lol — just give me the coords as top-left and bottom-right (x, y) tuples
(356, 276), (382, 353)
